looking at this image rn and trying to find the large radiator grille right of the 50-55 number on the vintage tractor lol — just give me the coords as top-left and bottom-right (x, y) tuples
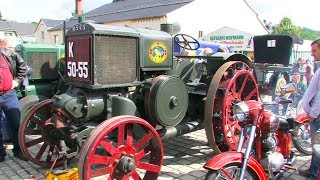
(94, 36), (137, 85)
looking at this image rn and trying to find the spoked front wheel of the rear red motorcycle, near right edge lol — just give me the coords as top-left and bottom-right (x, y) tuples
(292, 122), (312, 155)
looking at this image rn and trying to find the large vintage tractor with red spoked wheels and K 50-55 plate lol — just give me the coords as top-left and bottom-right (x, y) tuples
(19, 23), (259, 179)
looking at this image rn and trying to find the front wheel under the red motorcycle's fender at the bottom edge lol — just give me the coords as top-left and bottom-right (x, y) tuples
(205, 163), (259, 180)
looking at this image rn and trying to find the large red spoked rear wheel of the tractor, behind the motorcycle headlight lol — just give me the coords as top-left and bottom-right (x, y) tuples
(205, 61), (259, 153)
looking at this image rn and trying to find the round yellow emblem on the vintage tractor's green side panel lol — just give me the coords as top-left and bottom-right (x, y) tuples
(149, 42), (168, 63)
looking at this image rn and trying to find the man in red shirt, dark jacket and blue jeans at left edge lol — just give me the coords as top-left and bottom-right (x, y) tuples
(0, 38), (27, 162)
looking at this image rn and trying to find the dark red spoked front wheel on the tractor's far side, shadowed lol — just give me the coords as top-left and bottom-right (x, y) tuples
(19, 99), (76, 167)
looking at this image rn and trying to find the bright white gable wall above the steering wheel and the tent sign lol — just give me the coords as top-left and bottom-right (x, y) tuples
(167, 0), (268, 37)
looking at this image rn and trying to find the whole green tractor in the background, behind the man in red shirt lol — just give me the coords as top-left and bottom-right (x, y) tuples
(2, 43), (66, 140)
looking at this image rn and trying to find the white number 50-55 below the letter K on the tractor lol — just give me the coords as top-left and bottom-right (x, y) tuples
(67, 61), (88, 78)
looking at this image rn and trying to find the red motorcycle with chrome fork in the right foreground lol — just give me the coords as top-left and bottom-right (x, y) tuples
(204, 100), (296, 180)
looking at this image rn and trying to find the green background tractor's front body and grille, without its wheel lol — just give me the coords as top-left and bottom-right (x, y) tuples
(15, 44), (65, 98)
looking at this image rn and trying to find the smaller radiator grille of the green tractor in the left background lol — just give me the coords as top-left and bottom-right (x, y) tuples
(27, 52), (58, 79)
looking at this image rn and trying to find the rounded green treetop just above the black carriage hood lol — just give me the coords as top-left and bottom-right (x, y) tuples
(272, 17), (301, 37)
